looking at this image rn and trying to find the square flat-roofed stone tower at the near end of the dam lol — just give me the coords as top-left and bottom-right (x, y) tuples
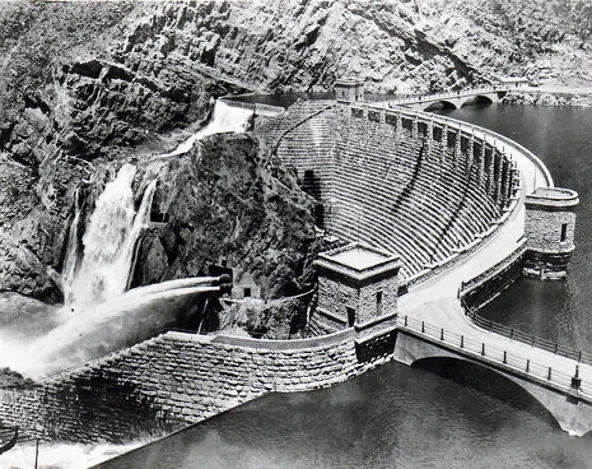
(315, 243), (401, 332)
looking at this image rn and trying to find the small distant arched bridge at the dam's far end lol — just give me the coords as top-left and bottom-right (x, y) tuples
(388, 85), (515, 111)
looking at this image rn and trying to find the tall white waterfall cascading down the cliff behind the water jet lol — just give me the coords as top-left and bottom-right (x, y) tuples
(64, 163), (156, 312)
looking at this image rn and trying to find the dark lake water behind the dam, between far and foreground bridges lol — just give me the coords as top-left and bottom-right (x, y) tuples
(451, 105), (592, 351)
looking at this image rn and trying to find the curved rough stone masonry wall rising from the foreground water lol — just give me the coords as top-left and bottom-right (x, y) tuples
(0, 330), (389, 442)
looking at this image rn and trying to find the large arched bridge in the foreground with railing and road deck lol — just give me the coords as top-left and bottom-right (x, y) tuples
(394, 316), (592, 436)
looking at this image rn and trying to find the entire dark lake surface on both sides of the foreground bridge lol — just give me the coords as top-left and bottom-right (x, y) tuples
(95, 105), (592, 469)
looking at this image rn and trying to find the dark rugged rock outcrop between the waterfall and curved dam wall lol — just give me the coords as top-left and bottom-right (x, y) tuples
(134, 135), (318, 298)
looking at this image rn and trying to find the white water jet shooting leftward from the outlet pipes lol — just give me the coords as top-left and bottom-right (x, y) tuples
(0, 277), (219, 378)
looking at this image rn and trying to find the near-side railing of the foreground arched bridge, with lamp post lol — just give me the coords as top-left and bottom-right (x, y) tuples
(397, 316), (592, 399)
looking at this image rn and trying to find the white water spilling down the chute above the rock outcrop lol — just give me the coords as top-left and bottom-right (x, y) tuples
(162, 100), (253, 156)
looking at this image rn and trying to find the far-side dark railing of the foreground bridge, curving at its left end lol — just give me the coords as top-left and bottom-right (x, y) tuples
(461, 298), (592, 365)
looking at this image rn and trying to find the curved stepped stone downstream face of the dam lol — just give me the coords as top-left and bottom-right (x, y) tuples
(268, 102), (519, 279)
